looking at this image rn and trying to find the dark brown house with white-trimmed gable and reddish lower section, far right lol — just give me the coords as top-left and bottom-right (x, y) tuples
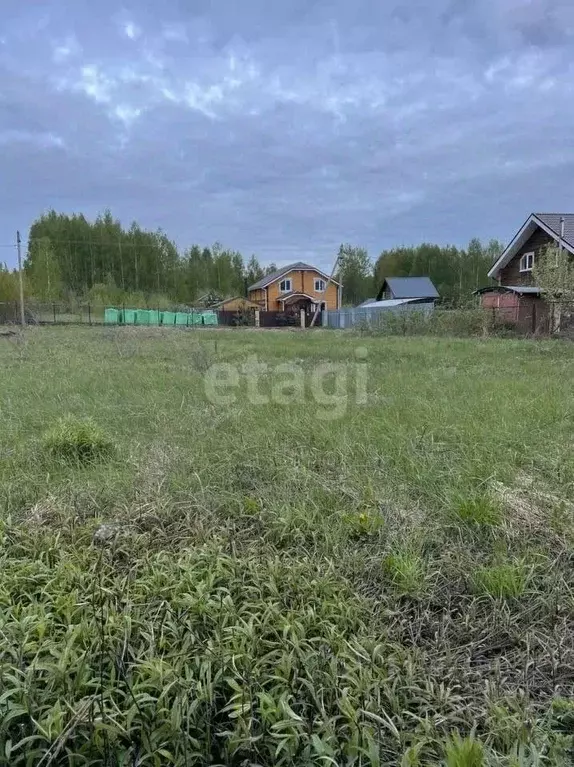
(476, 213), (574, 333)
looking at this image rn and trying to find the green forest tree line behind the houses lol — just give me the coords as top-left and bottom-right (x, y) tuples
(0, 210), (503, 306)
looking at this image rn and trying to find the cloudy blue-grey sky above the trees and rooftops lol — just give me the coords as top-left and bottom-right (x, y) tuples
(0, 0), (574, 268)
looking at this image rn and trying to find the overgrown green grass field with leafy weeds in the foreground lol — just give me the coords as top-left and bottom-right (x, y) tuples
(0, 328), (574, 767)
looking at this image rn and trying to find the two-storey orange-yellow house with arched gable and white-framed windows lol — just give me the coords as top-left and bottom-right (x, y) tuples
(248, 261), (342, 313)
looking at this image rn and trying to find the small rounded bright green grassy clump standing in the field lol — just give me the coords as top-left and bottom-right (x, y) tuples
(43, 415), (115, 464)
